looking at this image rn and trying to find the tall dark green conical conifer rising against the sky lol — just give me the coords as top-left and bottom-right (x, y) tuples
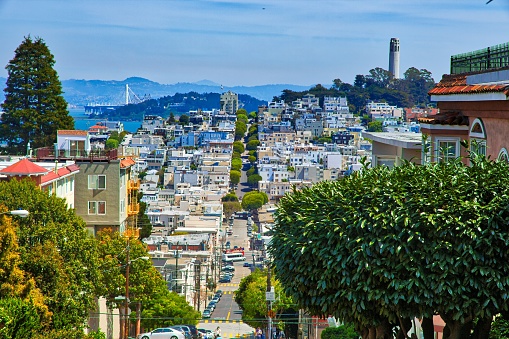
(0, 36), (74, 154)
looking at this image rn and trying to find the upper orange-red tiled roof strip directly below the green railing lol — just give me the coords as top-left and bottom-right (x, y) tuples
(428, 74), (509, 95)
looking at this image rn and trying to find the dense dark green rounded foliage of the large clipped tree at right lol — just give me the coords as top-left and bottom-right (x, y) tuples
(269, 155), (509, 339)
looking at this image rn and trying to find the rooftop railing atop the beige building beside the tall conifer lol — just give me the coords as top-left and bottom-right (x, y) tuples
(36, 147), (118, 161)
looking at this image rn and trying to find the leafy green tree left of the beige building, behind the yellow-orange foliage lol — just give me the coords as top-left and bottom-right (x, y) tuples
(0, 180), (99, 331)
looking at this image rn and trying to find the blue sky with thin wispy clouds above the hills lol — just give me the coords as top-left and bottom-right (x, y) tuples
(0, 0), (509, 87)
